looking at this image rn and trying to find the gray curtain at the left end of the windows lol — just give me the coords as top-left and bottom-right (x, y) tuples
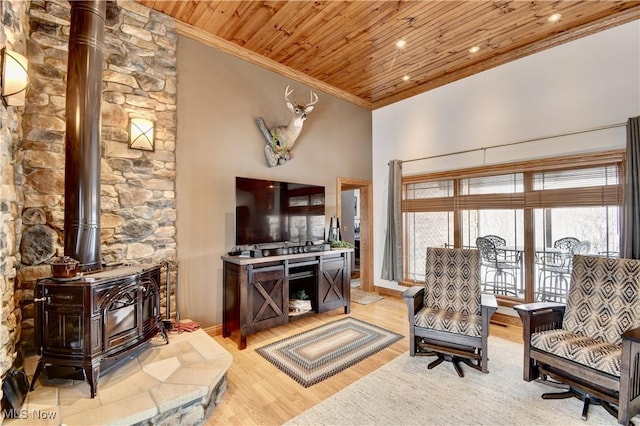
(382, 160), (404, 282)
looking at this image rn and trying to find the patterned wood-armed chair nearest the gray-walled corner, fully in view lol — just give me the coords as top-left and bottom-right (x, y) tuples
(403, 247), (498, 377)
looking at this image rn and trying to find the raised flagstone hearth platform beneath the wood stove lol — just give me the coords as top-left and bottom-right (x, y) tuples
(2, 330), (233, 426)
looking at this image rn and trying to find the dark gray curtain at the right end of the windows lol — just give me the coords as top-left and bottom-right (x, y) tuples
(620, 117), (640, 259)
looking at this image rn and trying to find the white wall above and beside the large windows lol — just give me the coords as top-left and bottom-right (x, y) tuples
(373, 21), (640, 288)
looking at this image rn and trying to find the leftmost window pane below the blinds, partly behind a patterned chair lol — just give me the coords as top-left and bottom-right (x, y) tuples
(404, 212), (453, 282)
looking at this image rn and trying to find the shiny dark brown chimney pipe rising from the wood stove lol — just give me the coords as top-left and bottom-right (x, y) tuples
(64, 0), (106, 271)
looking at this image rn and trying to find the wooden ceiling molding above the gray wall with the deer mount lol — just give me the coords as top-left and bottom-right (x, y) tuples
(174, 19), (372, 110)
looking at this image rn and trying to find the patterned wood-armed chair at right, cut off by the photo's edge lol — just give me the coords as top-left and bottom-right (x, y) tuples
(514, 255), (640, 424)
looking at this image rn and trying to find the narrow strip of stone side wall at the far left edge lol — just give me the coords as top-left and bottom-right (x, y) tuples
(0, 0), (29, 406)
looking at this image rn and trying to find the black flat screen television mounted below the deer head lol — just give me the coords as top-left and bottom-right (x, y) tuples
(236, 177), (325, 246)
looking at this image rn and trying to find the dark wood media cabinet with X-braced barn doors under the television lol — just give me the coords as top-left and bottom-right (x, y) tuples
(222, 250), (352, 349)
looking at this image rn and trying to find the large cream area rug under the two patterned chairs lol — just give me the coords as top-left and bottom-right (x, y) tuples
(286, 337), (640, 426)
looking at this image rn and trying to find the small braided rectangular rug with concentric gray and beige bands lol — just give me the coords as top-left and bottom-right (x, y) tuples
(256, 317), (402, 388)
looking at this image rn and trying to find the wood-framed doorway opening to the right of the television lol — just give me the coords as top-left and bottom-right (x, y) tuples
(336, 178), (373, 292)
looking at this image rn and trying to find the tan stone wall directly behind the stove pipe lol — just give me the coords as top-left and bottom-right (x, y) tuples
(16, 0), (177, 353)
